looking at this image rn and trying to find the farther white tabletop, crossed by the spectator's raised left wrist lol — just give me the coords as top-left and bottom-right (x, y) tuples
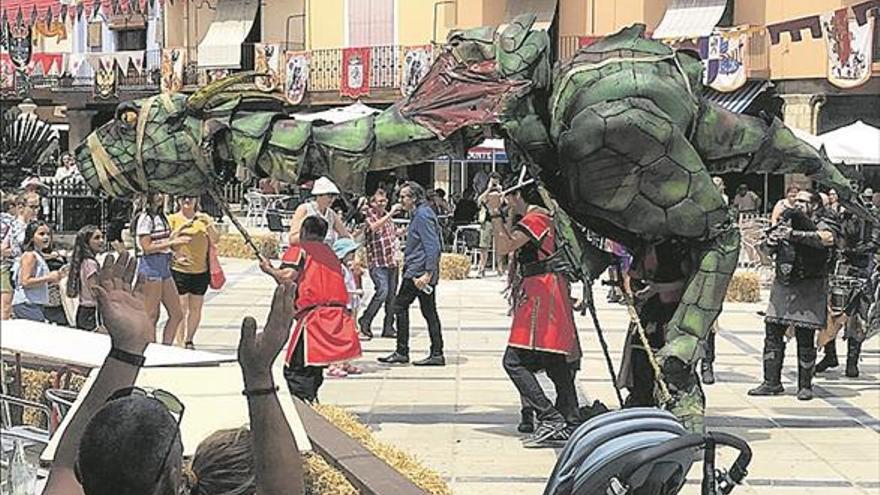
(0, 320), (236, 368)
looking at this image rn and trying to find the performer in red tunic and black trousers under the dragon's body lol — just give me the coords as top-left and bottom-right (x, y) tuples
(487, 176), (581, 446)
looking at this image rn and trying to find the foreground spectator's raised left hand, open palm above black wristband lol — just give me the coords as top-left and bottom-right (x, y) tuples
(94, 252), (156, 354)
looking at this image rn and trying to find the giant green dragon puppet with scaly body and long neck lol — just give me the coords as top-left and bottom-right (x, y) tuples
(77, 15), (866, 430)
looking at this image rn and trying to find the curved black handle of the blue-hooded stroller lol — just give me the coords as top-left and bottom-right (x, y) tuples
(617, 432), (752, 494)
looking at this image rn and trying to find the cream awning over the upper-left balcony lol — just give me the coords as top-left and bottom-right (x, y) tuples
(198, 0), (260, 69)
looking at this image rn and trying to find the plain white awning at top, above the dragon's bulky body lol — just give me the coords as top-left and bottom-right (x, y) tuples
(652, 0), (727, 39)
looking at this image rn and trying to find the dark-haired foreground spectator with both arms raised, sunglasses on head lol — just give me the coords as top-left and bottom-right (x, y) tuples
(43, 254), (303, 495)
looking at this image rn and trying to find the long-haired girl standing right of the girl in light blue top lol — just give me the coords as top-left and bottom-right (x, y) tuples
(67, 225), (104, 332)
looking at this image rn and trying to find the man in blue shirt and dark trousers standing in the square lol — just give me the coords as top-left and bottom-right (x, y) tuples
(379, 182), (446, 366)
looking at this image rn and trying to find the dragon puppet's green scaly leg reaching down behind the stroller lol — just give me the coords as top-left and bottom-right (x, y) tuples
(657, 227), (740, 432)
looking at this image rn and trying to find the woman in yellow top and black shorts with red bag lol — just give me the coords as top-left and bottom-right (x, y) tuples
(168, 196), (220, 349)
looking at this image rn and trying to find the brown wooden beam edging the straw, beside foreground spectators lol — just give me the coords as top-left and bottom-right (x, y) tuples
(293, 398), (428, 495)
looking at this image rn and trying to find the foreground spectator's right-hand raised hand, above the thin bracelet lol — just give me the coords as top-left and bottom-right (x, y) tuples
(238, 283), (296, 386)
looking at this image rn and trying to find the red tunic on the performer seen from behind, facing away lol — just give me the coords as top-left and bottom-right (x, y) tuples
(282, 242), (361, 366)
